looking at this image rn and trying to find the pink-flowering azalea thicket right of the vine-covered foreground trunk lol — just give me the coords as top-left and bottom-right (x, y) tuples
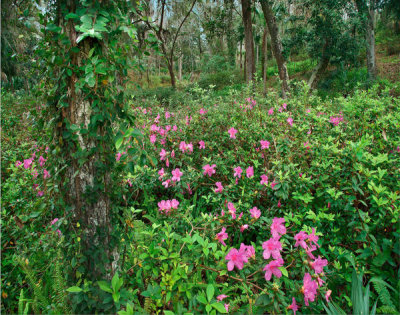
(111, 82), (400, 313)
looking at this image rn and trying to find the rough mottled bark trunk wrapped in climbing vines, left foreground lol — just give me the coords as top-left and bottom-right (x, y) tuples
(63, 0), (112, 279)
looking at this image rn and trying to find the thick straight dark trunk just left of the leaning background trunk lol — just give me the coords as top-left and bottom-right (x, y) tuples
(241, 0), (256, 83)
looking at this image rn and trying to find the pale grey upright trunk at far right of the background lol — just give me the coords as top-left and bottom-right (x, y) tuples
(366, 0), (377, 81)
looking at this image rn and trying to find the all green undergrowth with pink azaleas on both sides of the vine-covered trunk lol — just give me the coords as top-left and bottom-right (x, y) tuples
(2, 83), (400, 314)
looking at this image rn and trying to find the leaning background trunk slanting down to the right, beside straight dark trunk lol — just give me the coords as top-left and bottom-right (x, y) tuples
(260, 0), (289, 98)
